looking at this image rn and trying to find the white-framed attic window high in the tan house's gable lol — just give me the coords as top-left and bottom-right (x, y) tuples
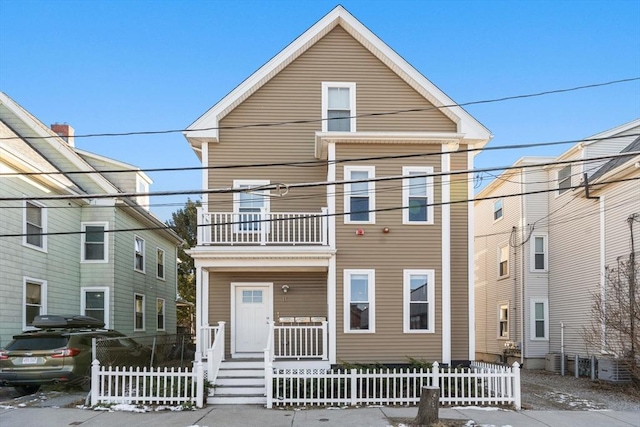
(322, 82), (356, 132)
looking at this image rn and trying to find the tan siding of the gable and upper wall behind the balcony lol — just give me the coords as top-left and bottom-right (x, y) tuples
(208, 27), (456, 212)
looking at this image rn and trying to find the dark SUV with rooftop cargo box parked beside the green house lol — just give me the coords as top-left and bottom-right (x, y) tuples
(0, 315), (151, 394)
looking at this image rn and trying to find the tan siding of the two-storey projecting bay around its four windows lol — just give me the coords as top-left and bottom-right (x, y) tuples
(336, 144), (442, 363)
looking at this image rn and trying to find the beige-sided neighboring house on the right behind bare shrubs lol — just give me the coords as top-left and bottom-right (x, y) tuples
(475, 119), (640, 371)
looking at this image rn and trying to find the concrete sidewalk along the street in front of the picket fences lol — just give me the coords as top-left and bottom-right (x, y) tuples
(0, 405), (640, 427)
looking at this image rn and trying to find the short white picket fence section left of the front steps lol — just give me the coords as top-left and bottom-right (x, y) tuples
(91, 360), (204, 408)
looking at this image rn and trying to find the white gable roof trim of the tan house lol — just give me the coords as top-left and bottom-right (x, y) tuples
(184, 6), (491, 152)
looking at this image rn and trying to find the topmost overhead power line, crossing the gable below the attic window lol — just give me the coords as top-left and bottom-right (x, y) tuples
(0, 77), (640, 140)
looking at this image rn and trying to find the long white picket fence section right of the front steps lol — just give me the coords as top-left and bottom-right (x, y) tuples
(266, 362), (521, 409)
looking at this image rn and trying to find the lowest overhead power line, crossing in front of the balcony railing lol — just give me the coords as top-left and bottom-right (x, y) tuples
(0, 177), (640, 238)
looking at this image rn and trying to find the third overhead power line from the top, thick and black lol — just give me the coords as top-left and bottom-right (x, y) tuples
(0, 151), (640, 201)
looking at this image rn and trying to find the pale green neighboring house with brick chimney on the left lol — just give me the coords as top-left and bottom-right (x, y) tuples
(0, 92), (182, 347)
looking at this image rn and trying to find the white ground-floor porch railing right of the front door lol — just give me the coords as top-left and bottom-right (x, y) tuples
(272, 321), (328, 360)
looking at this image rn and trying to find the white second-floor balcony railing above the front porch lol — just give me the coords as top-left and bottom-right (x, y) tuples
(198, 208), (329, 245)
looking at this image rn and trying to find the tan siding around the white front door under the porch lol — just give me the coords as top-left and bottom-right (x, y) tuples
(208, 271), (327, 356)
